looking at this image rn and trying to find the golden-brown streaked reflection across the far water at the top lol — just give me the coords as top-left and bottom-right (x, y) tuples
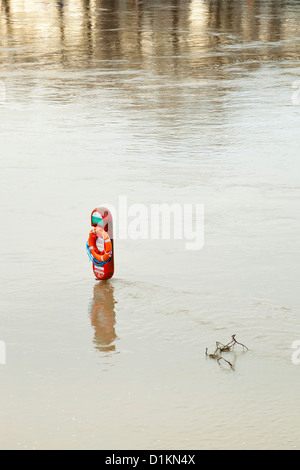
(0, 0), (300, 70)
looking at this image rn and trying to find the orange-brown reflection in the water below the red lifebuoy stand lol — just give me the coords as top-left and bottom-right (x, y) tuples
(90, 282), (117, 352)
